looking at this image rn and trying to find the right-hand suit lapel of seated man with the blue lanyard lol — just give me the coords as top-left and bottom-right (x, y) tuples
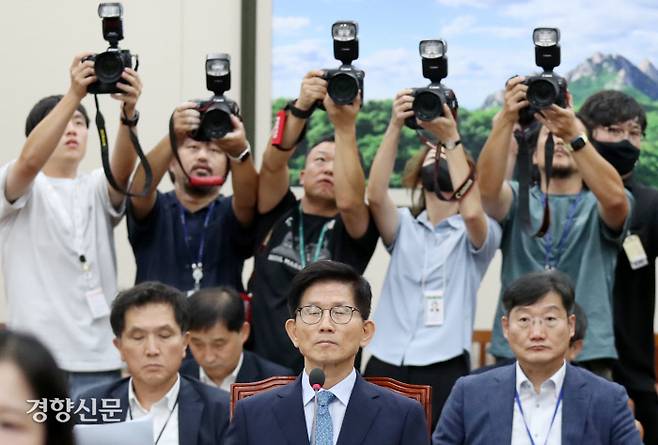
(562, 363), (591, 443)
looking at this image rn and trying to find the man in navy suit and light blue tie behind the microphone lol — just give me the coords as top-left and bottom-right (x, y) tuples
(227, 260), (429, 445)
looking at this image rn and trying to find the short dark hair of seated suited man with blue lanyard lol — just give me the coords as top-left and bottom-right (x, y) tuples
(503, 269), (575, 315)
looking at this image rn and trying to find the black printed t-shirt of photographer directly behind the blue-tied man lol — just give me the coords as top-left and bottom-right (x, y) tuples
(249, 191), (379, 372)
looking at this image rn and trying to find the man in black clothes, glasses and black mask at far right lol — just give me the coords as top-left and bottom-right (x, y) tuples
(578, 90), (658, 444)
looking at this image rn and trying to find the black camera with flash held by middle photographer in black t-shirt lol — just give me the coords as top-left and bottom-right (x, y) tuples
(323, 21), (365, 105)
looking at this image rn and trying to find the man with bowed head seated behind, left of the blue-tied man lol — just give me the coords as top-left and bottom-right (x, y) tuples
(181, 286), (292, 391)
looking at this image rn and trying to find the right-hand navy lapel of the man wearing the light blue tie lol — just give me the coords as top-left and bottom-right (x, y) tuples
(337, 374), (381, 445)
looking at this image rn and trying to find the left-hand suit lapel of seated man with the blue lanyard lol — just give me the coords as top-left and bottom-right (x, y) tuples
(485, 364), (516, 443)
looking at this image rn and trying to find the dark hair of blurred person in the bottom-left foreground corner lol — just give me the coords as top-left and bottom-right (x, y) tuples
(0, 330), (75, 445)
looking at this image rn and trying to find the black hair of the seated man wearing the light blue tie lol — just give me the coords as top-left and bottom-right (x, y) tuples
(288, 260), (372, 320)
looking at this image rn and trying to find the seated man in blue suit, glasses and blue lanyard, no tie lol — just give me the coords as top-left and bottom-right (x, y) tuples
(432, 270), (642, 445)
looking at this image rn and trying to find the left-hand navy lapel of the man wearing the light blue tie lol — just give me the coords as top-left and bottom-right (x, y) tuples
(272, 376), (309, 445)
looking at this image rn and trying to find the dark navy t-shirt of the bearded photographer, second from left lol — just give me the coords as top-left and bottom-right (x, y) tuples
(127, 191), (254, 291)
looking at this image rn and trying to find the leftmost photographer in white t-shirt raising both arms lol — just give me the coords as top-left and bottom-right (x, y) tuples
(0, 53), (142, 396)
